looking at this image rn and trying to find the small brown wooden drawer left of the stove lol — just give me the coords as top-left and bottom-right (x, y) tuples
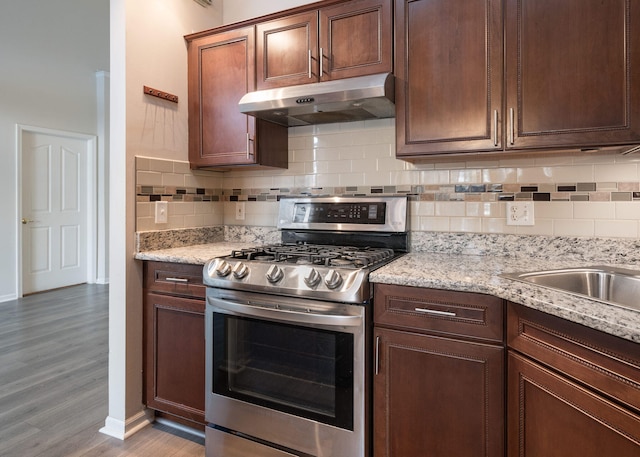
(144, 262), (206, 298)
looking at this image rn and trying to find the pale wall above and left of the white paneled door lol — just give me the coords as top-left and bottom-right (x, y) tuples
(0, 0), (109, 301)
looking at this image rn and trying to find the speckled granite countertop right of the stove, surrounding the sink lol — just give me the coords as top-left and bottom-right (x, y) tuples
(370, 252), (640, 343)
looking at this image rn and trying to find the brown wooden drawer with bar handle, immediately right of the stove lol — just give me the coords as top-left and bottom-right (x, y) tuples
(374, 284), (504, 343)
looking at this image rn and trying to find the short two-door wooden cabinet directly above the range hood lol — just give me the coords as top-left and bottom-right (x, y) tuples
(256, 0), (393, 89)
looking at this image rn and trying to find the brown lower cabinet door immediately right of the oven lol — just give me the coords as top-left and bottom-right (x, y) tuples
(374, 328), (504, 457)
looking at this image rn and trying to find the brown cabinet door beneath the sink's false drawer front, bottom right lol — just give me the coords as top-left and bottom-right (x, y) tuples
(507, 351), (640, 457)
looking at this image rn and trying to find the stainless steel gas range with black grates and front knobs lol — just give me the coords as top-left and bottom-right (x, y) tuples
(204, 197), (408, 457)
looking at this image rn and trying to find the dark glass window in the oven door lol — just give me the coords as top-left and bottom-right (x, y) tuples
(213, 313), (354, 430)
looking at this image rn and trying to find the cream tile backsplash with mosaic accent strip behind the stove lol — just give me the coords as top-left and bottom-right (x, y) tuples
(136, 119), (640, 238)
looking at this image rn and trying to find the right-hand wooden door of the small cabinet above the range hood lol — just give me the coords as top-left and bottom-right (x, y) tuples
(318, 0), (393, 81)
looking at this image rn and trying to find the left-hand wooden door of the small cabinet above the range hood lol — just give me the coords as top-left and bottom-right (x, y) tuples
(256, 11), (319, 89)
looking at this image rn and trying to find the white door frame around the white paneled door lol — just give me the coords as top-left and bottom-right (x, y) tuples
(16, 124), (98, 297)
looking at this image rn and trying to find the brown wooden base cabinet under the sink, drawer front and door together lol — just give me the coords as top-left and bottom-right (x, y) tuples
(507, 303), (640, 457)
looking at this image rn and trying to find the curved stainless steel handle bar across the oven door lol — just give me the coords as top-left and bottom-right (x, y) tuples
(207, 297), (362, 327)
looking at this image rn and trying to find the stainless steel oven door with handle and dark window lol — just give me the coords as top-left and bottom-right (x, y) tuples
(206, 289), (368, 457)
